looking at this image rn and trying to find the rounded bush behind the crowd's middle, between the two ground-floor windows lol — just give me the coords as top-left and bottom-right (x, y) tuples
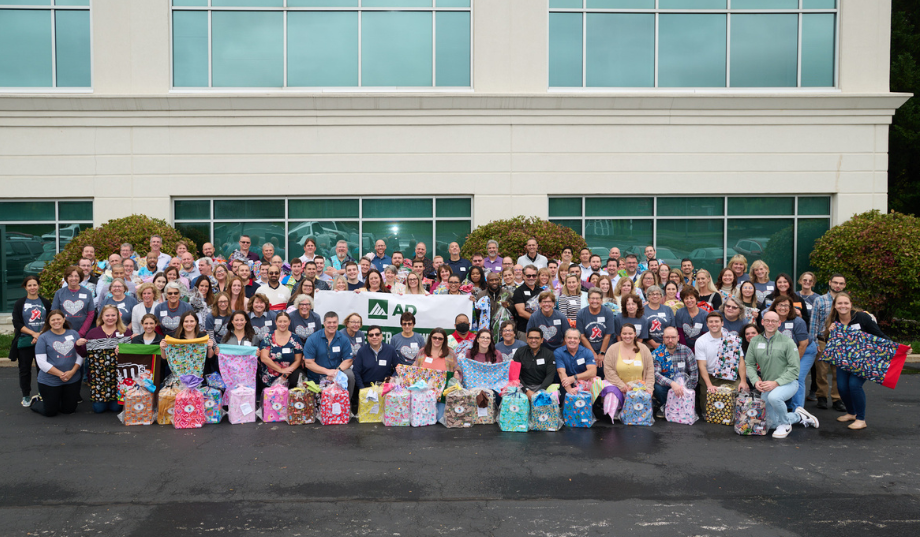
(460, 216), (587, 259)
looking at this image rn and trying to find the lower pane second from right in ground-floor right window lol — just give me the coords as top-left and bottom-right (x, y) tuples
(728, 218), (793, 279)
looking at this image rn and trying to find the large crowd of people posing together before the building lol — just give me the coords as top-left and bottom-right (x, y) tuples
(11, 235), (885, 437)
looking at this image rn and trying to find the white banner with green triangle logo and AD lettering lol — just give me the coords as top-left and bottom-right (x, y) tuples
(313, 291), (473, 334)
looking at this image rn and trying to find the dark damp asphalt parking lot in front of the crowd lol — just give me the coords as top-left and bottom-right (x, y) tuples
(0, 368), (920, 537)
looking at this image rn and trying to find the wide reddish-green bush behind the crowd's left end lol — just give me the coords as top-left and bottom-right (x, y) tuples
(40, 214), (196, 300)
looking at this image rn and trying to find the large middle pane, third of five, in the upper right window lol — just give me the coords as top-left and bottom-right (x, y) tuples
(658, 14), (726, 88)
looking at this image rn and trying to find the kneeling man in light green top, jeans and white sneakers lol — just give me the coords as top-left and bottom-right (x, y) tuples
(744, 311), (818, 438)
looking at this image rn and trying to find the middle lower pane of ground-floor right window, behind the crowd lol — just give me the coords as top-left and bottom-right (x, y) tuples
(656, 219), (724, 278)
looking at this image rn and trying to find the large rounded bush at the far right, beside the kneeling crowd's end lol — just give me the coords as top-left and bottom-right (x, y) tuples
(811, 210), (920, 324)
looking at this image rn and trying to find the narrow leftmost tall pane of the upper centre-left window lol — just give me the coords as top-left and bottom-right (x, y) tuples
(173, 11), (208, 88)
